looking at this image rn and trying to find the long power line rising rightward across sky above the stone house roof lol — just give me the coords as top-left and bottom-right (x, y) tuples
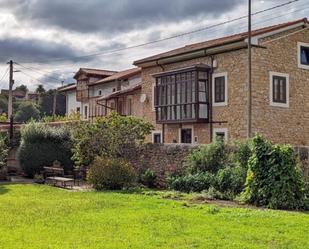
(19, 0), (300, 64)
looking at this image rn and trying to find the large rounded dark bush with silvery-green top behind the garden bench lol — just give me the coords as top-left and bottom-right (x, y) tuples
(19, 122), (73, 177)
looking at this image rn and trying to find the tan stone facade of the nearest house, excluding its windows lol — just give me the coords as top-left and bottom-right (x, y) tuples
(137, 24), (309, 145)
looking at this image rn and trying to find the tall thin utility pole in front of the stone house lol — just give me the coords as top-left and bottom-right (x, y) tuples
(247, 0), (252, 138)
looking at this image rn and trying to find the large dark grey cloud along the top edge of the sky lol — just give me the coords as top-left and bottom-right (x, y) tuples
(7, 0), (244, 34)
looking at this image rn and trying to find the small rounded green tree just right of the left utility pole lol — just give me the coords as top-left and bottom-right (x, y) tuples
(15, 102), (40, 122)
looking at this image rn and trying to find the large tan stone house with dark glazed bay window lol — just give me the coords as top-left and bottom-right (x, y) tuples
(134, 19), (309, 145)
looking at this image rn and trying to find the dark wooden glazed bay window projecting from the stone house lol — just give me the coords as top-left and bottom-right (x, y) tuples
(154, 65), (209, 123)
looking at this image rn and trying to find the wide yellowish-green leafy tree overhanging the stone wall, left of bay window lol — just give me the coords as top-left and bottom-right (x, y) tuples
(73, 112), (153, 165)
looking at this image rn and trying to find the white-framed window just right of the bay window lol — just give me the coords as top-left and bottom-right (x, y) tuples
(212, 73), (227, 106)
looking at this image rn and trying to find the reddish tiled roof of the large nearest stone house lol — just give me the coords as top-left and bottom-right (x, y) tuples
(133, 18), (308, 65)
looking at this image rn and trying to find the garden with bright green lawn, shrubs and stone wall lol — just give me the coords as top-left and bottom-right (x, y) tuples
(0, 113), (309, 248)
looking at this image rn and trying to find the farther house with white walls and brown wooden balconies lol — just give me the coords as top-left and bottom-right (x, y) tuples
(59, 68), (141, 119)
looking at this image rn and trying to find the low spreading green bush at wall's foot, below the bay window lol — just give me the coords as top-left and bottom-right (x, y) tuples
(169, 173), (214, 193)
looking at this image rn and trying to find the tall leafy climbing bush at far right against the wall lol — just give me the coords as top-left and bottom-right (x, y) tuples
(243, 136), (306, 209)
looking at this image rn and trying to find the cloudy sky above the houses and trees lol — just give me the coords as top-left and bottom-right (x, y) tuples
(0, 0), (309, 89)
